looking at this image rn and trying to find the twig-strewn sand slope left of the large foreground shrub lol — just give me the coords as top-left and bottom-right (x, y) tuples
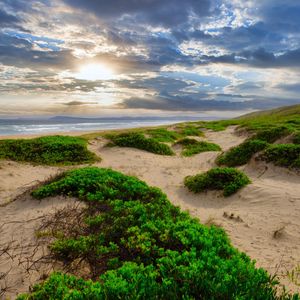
(0, 196), (75, 299)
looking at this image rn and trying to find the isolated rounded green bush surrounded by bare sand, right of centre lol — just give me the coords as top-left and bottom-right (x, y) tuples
(184, 168), (251, 196)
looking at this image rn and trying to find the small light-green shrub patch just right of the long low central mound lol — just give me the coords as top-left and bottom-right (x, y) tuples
(176, 138), (221, 156)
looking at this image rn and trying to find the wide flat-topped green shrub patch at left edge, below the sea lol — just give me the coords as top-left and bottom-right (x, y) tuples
(0, 136), (99, 165)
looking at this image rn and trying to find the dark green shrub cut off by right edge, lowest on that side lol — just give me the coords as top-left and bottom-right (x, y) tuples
(260, 144), (300, 168)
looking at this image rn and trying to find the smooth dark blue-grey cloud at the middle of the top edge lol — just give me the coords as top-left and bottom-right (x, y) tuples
(65, 0), (210, 26)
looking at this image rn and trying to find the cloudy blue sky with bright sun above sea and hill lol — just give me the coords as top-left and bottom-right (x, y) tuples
(0, 0), (300, 117)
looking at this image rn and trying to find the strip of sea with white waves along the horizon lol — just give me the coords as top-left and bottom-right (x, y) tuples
(0, 116), (213, 136)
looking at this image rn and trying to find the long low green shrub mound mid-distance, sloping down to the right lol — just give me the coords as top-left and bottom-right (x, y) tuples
(109, 132), (174, 155)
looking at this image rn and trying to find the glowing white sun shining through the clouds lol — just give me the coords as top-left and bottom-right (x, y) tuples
(75, 63), (115, 80)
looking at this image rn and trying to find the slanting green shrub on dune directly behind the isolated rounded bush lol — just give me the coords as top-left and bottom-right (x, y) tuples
(216, 139), (268, 167)
